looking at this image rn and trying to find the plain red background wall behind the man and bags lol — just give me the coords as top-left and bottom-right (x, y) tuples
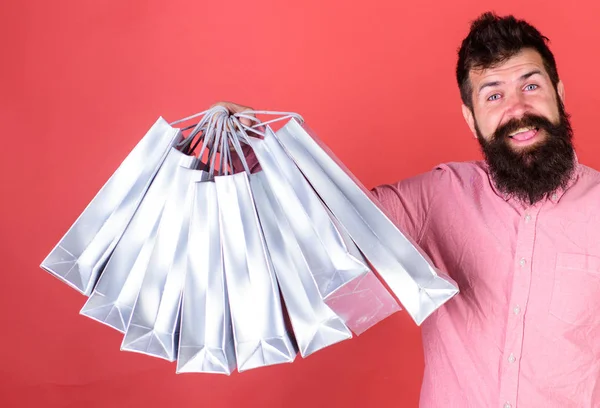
(0, 0), (600, 408)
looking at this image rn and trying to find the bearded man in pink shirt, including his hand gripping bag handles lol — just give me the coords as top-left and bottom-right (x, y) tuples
(214, 13), (600, 408)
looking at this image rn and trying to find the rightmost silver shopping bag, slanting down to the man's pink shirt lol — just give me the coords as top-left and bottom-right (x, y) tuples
(276, 119), (458, 325)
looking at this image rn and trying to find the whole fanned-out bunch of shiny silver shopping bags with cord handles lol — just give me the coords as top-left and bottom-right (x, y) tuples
(41, 106), (458, 374)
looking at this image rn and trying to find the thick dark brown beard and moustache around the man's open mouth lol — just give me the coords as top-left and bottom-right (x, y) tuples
(475, 101), (575, 205)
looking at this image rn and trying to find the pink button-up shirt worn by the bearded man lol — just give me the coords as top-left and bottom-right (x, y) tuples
(373, 162), (600, 408)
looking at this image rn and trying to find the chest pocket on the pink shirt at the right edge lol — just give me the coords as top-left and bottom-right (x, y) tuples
(549, 252), (600, 326)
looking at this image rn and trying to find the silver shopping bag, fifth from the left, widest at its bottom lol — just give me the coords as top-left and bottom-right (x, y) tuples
(215, 172), (296, 372)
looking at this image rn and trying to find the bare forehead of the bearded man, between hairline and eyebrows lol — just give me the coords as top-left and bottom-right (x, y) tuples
(469, 48), (547, 87)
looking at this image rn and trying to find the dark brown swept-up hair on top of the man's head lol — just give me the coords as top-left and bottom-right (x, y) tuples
(456, 12), (559, 110)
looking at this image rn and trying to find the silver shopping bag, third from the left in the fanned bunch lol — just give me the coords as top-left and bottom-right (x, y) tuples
(121, 167), (208, 361)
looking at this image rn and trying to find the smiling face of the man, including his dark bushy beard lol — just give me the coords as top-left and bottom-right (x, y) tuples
(463, 49), (575, 203)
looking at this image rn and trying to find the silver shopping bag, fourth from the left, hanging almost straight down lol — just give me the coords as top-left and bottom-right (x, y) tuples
(177, 181), (236, 375)
